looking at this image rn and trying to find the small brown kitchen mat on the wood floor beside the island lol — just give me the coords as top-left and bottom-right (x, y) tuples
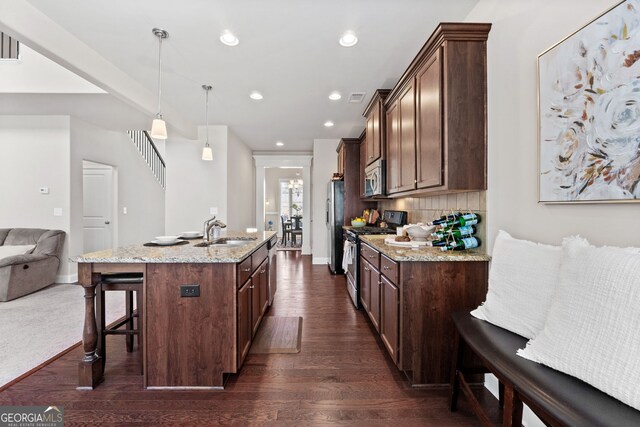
(249, 316), (302, 354)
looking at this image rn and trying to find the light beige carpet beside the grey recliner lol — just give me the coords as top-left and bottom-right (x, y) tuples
(0, 284), (125, 386)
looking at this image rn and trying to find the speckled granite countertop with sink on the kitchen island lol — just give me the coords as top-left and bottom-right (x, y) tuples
(72, 231), (276, 263)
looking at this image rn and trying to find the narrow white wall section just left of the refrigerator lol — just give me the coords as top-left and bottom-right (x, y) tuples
(311, 139), (340, 264)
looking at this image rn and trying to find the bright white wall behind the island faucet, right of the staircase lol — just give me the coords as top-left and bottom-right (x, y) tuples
(165, 126), (228, 234)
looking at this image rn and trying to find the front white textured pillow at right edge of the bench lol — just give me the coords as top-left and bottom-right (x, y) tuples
(518, 240), (640, 410)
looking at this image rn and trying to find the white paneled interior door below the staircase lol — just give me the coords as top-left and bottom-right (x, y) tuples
(82, 166), (113, 253)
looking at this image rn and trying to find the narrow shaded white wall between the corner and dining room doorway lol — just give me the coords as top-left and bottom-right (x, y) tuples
(226, 130), (256, 231)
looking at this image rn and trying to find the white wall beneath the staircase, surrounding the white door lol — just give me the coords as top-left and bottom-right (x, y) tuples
(69, 117), (165, 273)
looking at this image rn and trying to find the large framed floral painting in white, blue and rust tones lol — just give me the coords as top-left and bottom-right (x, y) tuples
(538, 0), (640, 202)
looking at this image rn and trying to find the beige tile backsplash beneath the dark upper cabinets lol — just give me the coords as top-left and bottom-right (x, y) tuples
(378, 191), (487, 247)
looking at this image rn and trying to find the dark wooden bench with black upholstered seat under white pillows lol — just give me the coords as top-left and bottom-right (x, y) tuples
(451, 313), (640, 426)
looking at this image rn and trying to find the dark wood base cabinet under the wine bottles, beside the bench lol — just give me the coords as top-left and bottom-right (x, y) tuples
(361, 244), (489, 386)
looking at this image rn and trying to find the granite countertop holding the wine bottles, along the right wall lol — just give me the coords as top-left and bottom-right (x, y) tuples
(359, 234), (491, 261)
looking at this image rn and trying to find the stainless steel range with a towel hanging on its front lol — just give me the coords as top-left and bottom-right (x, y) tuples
(343, 211), (407, 308)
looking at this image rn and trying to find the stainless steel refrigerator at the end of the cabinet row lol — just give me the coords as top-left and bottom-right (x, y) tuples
(326, 181), (344, 274)
